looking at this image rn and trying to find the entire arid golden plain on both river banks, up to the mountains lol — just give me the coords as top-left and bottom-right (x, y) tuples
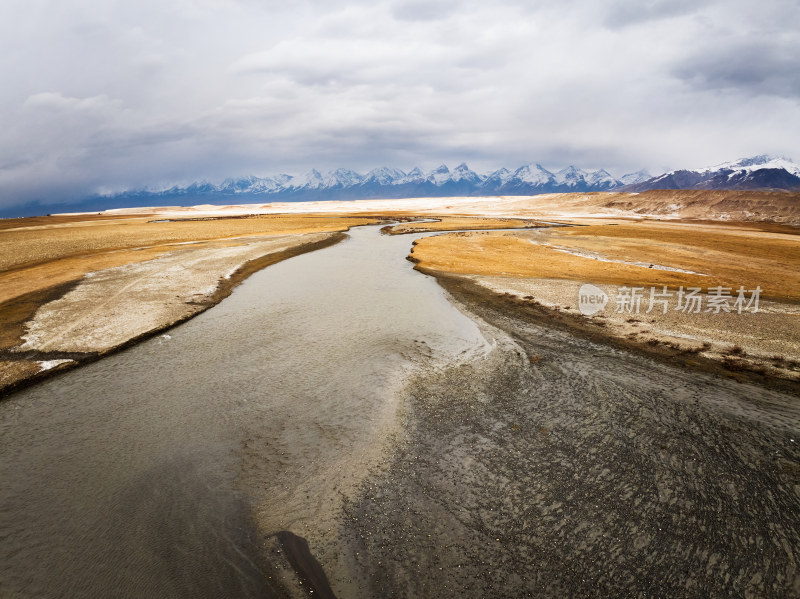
(0, 191), (800, 392)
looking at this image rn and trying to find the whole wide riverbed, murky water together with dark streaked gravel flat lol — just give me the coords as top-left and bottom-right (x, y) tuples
(0, 227), (800, 597)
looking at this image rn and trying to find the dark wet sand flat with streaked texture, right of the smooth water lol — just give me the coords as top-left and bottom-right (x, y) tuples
(341, 279), (800, 598)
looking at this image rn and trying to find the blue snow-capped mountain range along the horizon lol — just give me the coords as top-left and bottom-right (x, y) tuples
(39, 156), (800, 216)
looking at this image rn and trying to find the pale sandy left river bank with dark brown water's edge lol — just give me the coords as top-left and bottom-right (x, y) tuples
(0, 232), (346, 398)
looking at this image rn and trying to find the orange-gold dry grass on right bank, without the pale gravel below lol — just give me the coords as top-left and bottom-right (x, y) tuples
(413, 219), (800, 301)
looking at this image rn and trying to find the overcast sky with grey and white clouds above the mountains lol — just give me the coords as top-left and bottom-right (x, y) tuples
(0, 0), (800, 206)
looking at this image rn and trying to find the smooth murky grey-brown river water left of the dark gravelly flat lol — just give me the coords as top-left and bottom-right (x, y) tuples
(0, 227), (486, 597)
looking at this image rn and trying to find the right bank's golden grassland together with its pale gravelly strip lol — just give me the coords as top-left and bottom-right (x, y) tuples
(412, 219), (800, 380)
